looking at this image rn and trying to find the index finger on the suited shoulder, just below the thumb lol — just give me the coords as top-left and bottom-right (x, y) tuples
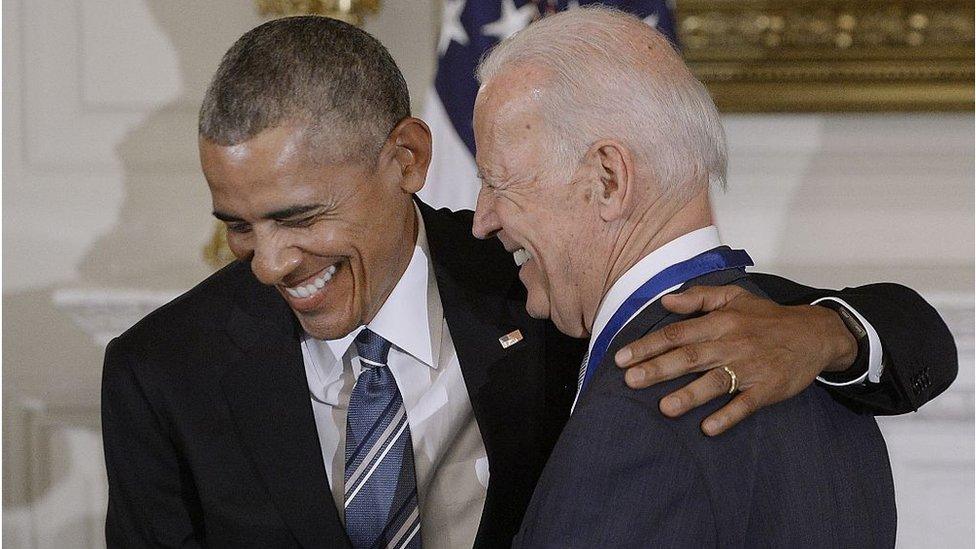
(614, 313), (728, 368)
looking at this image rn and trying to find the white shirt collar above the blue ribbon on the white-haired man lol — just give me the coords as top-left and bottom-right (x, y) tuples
(589, 225), (722, 351)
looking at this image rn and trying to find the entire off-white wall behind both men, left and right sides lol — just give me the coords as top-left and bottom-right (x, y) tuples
(3, 0), (974, 547)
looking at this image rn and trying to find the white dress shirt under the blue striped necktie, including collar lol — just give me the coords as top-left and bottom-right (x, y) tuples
(302, 211), (489, 548)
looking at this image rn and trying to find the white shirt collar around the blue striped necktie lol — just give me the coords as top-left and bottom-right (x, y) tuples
(320, 205), (440, 369)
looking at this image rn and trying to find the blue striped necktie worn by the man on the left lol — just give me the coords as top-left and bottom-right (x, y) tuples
(345, 328), (421, 549)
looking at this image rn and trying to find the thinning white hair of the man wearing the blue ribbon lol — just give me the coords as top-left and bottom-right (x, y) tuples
(477, 6), (728, 191)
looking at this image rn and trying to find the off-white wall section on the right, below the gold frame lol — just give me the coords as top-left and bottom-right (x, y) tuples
(716, 114), (974, 548)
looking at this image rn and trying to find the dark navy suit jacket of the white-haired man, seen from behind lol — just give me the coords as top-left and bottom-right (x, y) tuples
(515, 270), (896, 548)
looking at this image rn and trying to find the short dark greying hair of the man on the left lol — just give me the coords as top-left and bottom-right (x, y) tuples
(199, 16), (410, 159)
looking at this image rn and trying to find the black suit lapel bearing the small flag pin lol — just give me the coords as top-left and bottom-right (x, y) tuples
(418, 203), (549, 547)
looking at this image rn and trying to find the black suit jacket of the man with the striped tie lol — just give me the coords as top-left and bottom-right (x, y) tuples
(102, 204), (956, 547)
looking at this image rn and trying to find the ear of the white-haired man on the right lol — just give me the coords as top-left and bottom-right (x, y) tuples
(586, 139), (636, 222)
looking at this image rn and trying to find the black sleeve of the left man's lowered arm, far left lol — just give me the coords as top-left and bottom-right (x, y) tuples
(102, 339), (204, 548)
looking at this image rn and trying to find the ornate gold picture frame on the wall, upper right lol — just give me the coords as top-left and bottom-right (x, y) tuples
(675, 0), (974, 112)
